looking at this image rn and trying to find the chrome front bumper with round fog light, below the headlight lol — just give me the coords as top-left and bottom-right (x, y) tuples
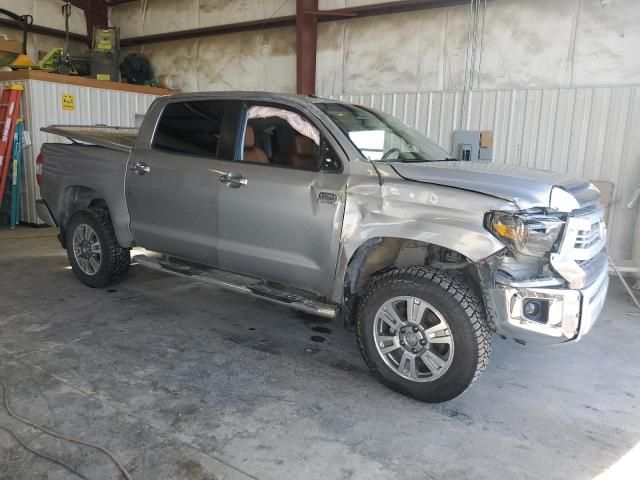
(486, 262), (609, 343)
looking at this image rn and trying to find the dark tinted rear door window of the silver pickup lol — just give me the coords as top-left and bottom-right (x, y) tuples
(153, 100), (227, 157)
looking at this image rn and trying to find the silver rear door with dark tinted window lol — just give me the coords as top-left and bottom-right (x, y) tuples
(126, 100), (232, 264)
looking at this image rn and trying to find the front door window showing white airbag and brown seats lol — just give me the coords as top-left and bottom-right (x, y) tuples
(242, 105), (320, 171)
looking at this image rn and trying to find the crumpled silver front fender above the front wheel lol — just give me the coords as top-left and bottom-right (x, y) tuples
(333, 162), (515, 302)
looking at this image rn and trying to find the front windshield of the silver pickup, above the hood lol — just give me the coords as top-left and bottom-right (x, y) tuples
(316, 103), (451, 162)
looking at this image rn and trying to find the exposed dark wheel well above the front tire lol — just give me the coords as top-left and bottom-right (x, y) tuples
(343, 237), (480, 322)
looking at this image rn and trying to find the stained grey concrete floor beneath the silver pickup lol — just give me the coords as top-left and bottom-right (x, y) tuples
(0, 228), (640, 480)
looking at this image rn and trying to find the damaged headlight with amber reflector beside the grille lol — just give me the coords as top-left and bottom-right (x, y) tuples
(485, 212), (565, 257)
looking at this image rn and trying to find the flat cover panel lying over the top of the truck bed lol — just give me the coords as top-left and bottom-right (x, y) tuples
(40, 125), (138, 152)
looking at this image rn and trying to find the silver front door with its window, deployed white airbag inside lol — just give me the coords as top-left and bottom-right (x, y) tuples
(216, 104), (347, 295)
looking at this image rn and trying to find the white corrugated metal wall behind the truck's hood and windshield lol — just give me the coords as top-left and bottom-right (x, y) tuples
(336, 85), (640, 262)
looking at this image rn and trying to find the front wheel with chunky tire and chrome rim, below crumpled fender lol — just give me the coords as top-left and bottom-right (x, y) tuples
(356, 266), (491, 403)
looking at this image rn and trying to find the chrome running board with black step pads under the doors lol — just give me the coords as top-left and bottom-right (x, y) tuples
(133, 255), (336, 318)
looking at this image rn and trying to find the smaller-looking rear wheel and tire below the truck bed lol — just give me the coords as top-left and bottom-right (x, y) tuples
(66, 208), (131, 288)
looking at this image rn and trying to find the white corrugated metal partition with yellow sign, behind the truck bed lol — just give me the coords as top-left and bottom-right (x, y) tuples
(0, 80), (156, 224)
